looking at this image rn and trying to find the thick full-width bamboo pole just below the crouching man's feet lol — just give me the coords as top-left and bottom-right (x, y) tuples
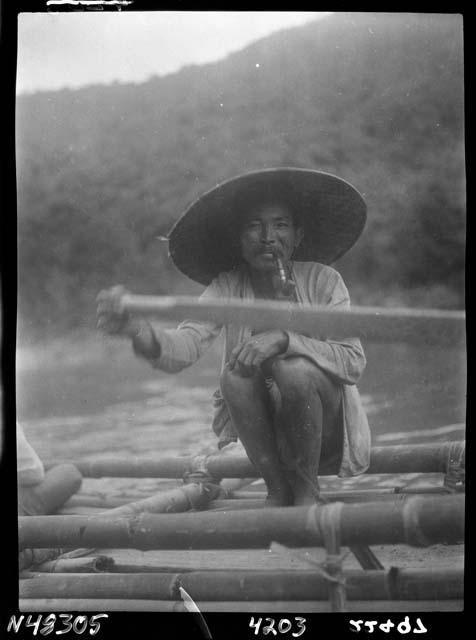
(18, 494), (464, 550)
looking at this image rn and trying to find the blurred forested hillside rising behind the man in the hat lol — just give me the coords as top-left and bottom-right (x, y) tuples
(17, 14), (465, 335)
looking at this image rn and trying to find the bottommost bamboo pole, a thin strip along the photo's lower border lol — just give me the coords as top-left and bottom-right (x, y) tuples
(19, 598), (463, 614)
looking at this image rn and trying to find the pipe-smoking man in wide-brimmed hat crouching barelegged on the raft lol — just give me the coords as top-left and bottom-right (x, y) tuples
(98, 168), (370, 506)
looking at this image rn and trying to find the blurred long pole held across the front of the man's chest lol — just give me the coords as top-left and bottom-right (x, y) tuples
(121, 294), (465, 346)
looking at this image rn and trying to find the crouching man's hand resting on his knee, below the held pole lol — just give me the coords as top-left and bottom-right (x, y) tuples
(228, 329), (288, 376)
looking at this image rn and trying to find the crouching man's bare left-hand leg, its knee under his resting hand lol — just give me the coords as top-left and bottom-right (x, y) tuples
(220, 369), (293, 506)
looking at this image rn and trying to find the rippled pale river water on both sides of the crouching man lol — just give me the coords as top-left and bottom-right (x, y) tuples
(17, 337), (466, 460)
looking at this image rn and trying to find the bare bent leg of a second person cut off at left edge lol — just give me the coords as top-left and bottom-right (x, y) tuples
(18, 464), (82, 515)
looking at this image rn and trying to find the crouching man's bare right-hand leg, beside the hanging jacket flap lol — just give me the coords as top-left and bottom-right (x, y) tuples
(270, 357), (341, 504)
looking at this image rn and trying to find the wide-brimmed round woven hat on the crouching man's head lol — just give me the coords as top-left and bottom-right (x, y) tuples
(168, 167), (367, 284)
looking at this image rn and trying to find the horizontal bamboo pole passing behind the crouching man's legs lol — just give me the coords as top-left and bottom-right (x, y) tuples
(61, 441), (465, 478)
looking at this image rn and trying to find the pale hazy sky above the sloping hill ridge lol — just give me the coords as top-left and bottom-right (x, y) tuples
(17, 11), (326, 93)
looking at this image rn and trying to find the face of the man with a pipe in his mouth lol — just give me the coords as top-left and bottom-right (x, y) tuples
(240, 204), (302, 271)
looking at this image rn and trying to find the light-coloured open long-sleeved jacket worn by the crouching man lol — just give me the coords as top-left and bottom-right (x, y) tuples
(139, 262), (370, 476)
